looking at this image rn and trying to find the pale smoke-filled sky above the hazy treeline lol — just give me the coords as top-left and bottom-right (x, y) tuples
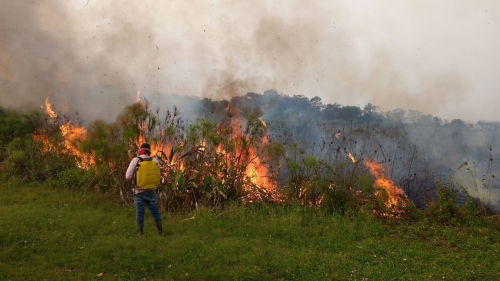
(0, 0), (500, 121)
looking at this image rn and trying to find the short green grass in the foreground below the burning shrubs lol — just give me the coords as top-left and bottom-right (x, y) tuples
(0, 178), (500, 280)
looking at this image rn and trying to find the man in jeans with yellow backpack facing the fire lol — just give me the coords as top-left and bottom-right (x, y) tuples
(125, 143), (163, 235)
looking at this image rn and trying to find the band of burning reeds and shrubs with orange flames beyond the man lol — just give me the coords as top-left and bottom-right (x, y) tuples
(25, 95), (416, 216)
